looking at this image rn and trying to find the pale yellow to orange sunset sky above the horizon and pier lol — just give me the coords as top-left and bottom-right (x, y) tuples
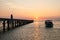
(0, 0), (60, 19)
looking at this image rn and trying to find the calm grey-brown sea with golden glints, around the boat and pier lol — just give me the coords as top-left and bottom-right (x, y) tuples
(0, 21), (60, 40)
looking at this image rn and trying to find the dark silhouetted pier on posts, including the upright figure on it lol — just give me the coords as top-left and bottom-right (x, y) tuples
(0, 15), (33, 32)
